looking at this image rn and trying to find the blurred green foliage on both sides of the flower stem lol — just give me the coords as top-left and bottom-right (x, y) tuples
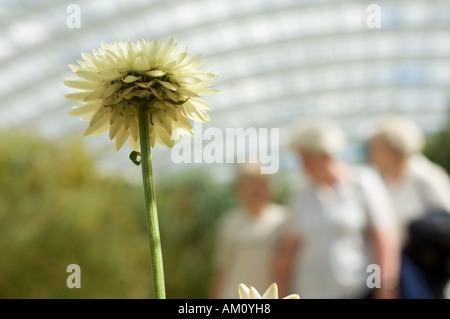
(0, 132), (234, 298)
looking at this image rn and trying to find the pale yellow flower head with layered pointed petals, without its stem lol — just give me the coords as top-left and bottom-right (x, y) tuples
(64, 39), (217, 151)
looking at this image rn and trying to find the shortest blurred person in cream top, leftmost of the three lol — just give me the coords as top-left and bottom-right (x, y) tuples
(212, 163), (287, 299)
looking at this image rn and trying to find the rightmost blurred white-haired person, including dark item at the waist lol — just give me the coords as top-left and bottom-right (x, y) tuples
(369, 115), (450, 298)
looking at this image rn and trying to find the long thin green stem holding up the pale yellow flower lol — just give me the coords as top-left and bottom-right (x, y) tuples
(138, 103), (166, 299)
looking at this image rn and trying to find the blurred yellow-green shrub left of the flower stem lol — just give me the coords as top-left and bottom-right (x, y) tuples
(0, 132), (151, 298)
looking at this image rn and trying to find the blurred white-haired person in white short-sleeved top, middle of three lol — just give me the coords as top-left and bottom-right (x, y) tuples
(277, 120), (399, 299)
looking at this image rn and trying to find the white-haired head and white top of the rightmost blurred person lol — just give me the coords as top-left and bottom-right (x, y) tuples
(369, 115), (450, 243)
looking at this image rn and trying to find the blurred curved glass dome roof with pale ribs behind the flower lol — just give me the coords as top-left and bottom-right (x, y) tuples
(0, 0), (450, 182)
